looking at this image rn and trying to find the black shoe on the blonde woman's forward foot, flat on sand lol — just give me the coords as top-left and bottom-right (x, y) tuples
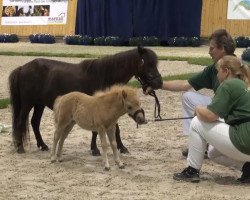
(173, 166), (200, 183)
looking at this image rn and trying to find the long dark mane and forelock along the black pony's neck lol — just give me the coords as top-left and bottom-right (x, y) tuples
(80, 48), (157, 88)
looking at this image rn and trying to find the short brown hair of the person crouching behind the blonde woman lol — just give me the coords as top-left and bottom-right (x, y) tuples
(209, 29), (235, 55)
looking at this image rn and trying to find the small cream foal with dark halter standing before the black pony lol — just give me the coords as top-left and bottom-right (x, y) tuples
(51, 85), (145, 170)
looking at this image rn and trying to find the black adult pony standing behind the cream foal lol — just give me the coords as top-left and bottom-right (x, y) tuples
(9, 47), (162, 155)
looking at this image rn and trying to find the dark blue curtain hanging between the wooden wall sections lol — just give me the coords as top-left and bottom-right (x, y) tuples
(75, 0), (202, 41)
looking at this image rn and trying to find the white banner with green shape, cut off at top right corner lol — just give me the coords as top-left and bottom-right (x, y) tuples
(227, 0), (250, 20)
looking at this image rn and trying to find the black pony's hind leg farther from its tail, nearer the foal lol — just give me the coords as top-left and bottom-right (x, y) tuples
(31, 105), (49, 151)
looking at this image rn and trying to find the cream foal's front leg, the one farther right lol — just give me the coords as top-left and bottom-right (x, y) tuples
(107, 127), (125, 169)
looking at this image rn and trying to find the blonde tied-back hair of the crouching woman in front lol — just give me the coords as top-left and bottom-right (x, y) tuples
(217, 55), (250, 85)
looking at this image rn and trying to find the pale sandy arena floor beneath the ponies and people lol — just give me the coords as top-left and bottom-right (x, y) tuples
(0, 43), (250, 200)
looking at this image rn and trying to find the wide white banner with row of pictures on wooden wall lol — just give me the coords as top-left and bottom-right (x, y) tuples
(1, 0), (68, 26)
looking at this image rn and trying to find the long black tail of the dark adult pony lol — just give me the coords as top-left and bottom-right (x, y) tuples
(9, 67), (28, 147)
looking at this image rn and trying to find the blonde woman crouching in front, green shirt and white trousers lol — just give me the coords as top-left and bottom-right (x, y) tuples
(173, 56), (250, 182)
